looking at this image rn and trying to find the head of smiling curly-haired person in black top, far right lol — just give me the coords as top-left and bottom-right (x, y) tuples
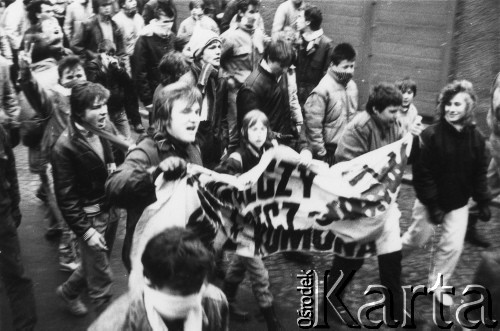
(437, 80), (477, 127)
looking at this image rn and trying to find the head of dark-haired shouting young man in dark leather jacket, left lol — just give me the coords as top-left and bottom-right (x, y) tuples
(70, 82), (109, 129)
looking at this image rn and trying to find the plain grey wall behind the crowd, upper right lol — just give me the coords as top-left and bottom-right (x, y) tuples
(176, 0), (500, 134)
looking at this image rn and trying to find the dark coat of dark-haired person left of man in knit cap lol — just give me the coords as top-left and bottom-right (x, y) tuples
(131, 34), (175, 106)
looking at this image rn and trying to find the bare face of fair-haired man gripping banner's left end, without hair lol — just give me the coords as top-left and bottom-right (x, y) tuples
(167, 99), (201, 143)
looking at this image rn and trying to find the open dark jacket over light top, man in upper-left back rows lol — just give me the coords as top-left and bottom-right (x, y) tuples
(72, 15), (125, 61)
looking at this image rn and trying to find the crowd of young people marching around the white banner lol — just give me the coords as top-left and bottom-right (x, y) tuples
(0, 0), (500, 330)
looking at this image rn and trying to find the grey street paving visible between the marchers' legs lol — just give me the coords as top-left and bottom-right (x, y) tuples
(0, 141), (500, 331)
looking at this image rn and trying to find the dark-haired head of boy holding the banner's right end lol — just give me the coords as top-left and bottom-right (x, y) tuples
(366, 83), (403, 127)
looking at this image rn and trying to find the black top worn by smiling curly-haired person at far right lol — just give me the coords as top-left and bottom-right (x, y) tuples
(413, 120), (491, 212)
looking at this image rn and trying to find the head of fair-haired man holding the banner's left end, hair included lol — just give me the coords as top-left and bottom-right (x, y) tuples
(153, 82), (202, 144)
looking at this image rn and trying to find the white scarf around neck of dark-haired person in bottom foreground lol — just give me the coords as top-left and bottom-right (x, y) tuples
(144, 285), (205, 331)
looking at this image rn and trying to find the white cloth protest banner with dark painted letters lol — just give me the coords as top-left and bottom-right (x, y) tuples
(132, 135), (412, 292)
